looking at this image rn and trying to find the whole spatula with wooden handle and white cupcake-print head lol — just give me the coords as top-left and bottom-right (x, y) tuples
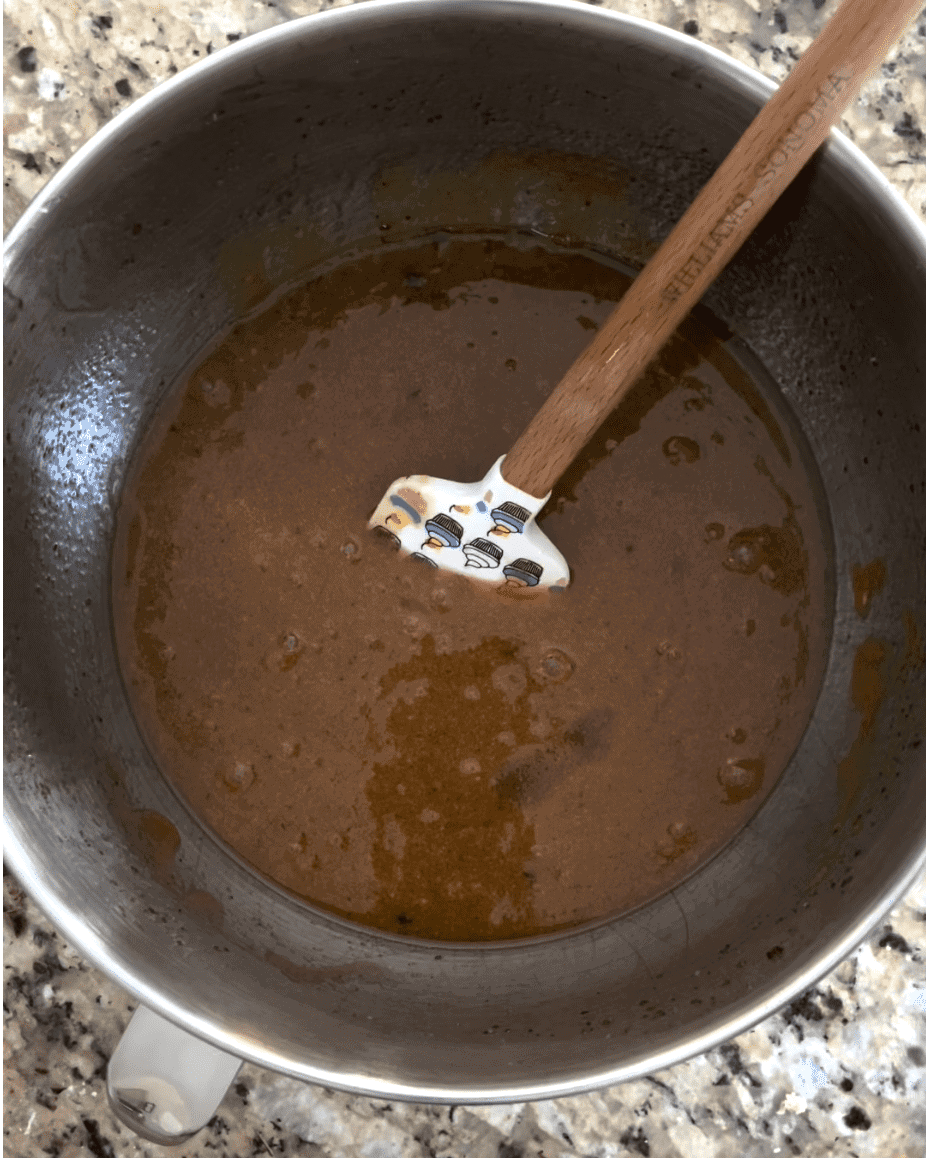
(369, 0), (923, 588)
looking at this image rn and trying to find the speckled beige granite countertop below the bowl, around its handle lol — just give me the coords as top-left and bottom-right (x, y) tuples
(3, 878), (926, 1158)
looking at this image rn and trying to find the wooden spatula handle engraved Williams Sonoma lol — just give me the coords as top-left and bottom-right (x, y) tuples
(502, 0), (923, 498)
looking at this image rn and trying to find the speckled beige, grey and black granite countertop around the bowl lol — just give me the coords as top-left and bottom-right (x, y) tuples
(3, 0), (926, 1158)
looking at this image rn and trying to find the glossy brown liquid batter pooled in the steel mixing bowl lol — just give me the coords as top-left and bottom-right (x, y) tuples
(113, 240), (825, 940)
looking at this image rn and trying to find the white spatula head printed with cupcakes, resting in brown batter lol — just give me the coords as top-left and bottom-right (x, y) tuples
(369, 456), (569, 589)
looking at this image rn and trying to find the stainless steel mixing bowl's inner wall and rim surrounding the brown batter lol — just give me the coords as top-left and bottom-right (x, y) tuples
(5, 0), (926, 1102)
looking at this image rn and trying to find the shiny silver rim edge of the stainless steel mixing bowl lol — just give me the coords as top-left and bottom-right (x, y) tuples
(3, 0), (926, 1105)
